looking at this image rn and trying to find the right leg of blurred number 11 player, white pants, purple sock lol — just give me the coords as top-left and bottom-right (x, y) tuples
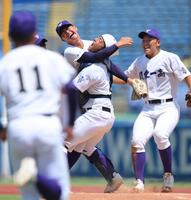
(36, 115), (70, 200)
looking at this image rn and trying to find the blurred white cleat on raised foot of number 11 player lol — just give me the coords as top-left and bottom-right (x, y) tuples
(13, 157), (37, 187)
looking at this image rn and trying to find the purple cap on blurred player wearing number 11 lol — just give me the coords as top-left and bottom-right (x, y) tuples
(9, 11), (36, 37)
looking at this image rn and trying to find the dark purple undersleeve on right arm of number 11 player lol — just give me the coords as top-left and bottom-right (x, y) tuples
(65, 81), (78, 126)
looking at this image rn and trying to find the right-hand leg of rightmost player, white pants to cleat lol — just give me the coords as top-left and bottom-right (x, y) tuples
(153, 104), (179, 192)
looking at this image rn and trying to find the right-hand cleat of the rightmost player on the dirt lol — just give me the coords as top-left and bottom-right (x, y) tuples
(161, 172), (174, 192)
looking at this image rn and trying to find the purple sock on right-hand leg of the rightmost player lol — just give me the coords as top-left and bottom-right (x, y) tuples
(159, 146), (172, 173)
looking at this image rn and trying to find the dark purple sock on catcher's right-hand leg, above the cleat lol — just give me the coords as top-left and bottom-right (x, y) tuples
(86, 148), (115, 183)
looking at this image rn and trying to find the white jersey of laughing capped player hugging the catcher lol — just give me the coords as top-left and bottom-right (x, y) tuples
(64, 40), (92, 67)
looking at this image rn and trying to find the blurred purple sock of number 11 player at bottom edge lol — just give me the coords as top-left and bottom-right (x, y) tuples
(36, 174), (61, 200)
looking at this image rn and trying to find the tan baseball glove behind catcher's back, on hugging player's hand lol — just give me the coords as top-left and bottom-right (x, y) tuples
(131, 79), (148, 100)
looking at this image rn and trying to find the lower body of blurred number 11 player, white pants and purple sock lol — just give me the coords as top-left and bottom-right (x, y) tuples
(9, 116), (70, 200)
